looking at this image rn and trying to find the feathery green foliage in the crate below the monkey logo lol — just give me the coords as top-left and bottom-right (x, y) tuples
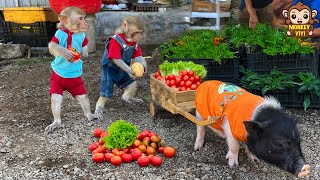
(222, 23), (314, 55)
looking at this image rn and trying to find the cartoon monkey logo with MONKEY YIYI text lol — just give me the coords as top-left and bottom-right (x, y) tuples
(282, 2), (319, 37)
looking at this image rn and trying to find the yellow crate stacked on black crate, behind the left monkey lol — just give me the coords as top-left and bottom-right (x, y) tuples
(1, 7), (58, 47)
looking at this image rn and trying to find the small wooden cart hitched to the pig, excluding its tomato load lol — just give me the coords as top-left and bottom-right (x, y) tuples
(149, 74), (219, 126)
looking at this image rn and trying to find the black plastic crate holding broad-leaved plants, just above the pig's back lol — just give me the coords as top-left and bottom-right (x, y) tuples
(251, 88), (320, 108)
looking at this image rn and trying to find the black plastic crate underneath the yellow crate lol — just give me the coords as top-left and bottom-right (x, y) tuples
(1, 21), (56, 47)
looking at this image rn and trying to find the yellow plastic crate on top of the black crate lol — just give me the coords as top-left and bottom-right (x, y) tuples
(3, 6), (58, 24)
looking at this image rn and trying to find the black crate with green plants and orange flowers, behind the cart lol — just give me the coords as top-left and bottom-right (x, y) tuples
(160, 30), (239, 84)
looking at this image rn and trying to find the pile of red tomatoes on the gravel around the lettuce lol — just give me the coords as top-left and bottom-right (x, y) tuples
(89, 128), (176, 167)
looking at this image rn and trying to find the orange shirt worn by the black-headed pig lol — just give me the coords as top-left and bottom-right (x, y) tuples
(195, 80), (263, 142)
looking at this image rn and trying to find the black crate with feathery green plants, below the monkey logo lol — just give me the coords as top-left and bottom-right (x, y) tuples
(223, 23), (319, 76)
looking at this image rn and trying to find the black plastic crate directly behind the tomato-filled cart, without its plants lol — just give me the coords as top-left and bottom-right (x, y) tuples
(167, 58), (240, 85)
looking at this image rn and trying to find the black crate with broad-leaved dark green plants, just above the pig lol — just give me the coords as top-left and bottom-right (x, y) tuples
(240, 67), (320, 111)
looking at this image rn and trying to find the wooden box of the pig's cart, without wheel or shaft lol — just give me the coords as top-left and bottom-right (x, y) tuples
(150, 74), (196, 114)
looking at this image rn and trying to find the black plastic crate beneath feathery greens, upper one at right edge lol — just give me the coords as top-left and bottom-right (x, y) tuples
(245, 52), (319, 77)
